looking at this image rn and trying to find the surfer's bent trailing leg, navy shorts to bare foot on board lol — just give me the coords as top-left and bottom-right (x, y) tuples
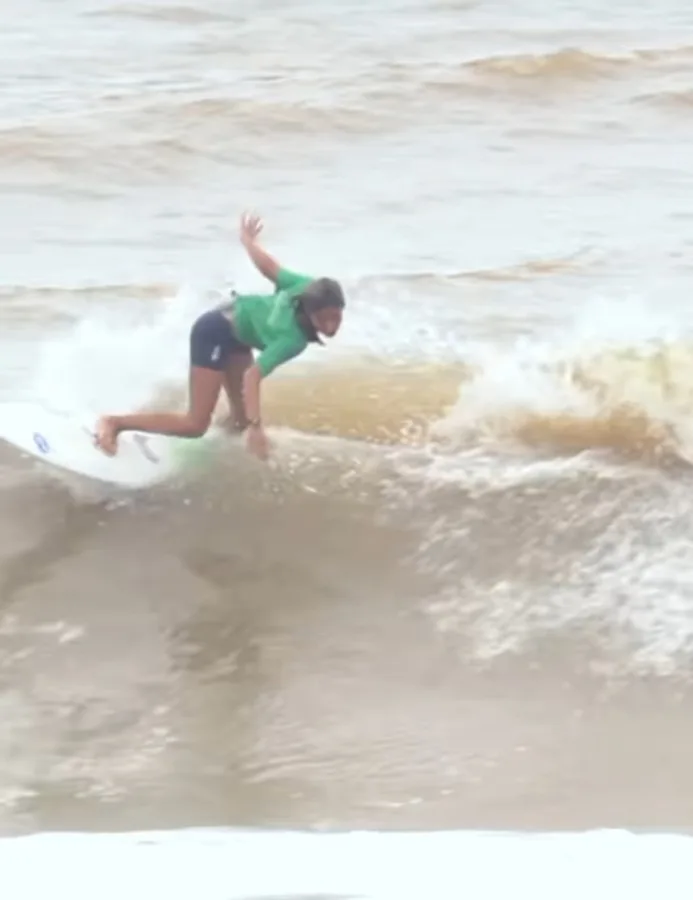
(96, 311), (231, 456)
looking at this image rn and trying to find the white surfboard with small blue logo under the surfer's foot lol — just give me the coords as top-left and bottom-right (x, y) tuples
(0, 403), (219, 488)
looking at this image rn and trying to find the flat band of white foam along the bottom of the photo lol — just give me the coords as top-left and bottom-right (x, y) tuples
(0, 829), (693, 900)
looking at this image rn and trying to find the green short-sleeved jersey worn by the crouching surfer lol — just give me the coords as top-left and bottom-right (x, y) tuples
(225, 269), (314, 378)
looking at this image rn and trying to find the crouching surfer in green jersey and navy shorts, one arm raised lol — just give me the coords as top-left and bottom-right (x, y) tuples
(96, 214), (345, 459)
